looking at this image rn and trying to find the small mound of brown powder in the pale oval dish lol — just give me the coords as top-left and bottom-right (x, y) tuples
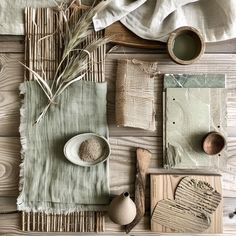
(79, 137), (107, 162)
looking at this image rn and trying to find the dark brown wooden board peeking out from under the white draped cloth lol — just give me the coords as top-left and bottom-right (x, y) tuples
(105, 22), (166, 49)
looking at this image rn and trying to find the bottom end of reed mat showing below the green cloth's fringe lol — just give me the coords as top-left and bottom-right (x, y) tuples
(22, 211), (105, 232)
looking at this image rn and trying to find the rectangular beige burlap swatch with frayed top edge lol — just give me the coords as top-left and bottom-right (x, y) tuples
(116, 59), (158, 131)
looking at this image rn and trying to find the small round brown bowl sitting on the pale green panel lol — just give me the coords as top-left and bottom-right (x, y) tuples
(202, 132), (226, 155)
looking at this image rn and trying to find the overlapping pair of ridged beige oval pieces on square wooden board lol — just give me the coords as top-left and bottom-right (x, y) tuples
(152, 177), (221, 233)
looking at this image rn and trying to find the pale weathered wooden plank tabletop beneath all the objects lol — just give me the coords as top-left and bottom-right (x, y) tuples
(0, 36), (236, 235)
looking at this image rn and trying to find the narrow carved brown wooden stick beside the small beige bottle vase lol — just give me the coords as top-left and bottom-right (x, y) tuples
(125, 148), (152, 233)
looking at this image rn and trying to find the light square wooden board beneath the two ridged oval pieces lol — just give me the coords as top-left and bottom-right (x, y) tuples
(150, 174), (223, 233)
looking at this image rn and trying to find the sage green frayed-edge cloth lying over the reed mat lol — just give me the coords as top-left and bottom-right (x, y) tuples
(17, 81), (109, 213)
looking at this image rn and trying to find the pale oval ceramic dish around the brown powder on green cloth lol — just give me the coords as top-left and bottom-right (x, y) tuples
(64, 133), (111, 167)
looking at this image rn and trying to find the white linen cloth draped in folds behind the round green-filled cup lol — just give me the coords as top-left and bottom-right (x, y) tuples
(93, 0), (236, 42)
